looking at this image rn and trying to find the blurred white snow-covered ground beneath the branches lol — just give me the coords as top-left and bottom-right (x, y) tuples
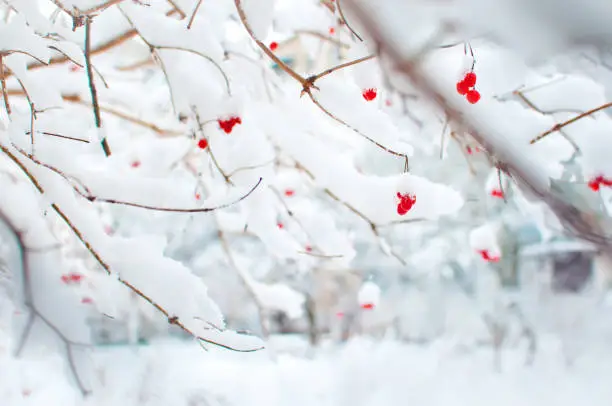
(10, 339), (612, 406)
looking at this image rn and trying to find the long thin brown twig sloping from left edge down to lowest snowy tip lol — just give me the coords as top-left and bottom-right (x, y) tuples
(0, 144), (262, 352)
